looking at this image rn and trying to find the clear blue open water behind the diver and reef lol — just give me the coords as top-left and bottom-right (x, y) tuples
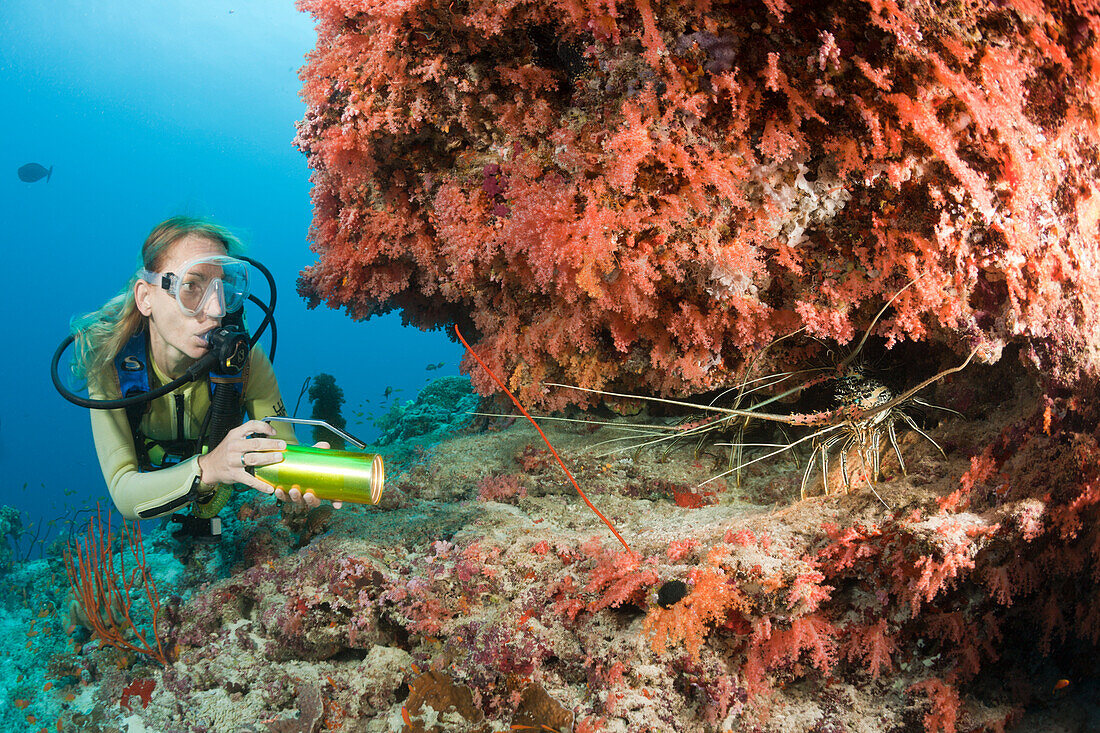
(0, 0), (461, 530)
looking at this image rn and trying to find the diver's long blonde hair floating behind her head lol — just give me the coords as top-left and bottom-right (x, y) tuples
(69, 217), (244, 382)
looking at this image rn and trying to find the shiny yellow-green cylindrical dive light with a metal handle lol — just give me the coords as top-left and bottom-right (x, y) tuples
(249, 417), (386, 504)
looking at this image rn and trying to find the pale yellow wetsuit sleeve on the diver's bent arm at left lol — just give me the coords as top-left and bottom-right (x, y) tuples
(89, 376), (199, 519)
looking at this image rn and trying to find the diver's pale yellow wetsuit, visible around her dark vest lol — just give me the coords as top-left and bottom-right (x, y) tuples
(89, 344), (298, 519)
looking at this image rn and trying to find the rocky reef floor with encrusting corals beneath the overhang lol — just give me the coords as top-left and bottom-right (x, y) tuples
(2, 352), (1100, 733)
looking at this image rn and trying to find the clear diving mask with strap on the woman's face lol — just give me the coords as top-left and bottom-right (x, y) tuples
(138, 254), (249, 316)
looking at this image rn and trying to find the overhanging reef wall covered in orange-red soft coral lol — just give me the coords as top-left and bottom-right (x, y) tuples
(297, 0), (1100, 407)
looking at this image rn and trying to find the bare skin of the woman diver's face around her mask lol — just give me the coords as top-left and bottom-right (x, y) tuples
(134, 234), (226, 378)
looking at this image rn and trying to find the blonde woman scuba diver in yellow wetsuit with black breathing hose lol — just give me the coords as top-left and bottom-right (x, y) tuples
(53, 217), (340, 541)
